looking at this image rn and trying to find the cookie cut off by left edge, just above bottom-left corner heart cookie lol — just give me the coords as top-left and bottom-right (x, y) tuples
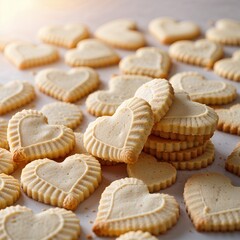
(0, 173), (21, 209)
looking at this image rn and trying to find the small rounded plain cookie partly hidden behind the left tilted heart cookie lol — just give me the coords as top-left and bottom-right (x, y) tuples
(40, 102), (83, 129)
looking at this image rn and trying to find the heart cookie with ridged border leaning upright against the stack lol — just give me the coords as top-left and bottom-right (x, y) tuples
(84, 97), (153, 163)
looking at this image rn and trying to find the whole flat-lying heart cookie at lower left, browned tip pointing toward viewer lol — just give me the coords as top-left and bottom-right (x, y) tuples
(21, 154), (101, 210)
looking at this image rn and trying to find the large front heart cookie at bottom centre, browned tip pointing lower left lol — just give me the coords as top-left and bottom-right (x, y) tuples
(93, 178), (179, 236)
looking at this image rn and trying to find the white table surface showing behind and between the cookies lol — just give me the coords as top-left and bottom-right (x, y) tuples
(0, 0), (240, 240)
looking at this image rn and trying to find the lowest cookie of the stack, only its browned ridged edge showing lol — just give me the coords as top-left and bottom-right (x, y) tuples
(171, 141), (215, 170)
